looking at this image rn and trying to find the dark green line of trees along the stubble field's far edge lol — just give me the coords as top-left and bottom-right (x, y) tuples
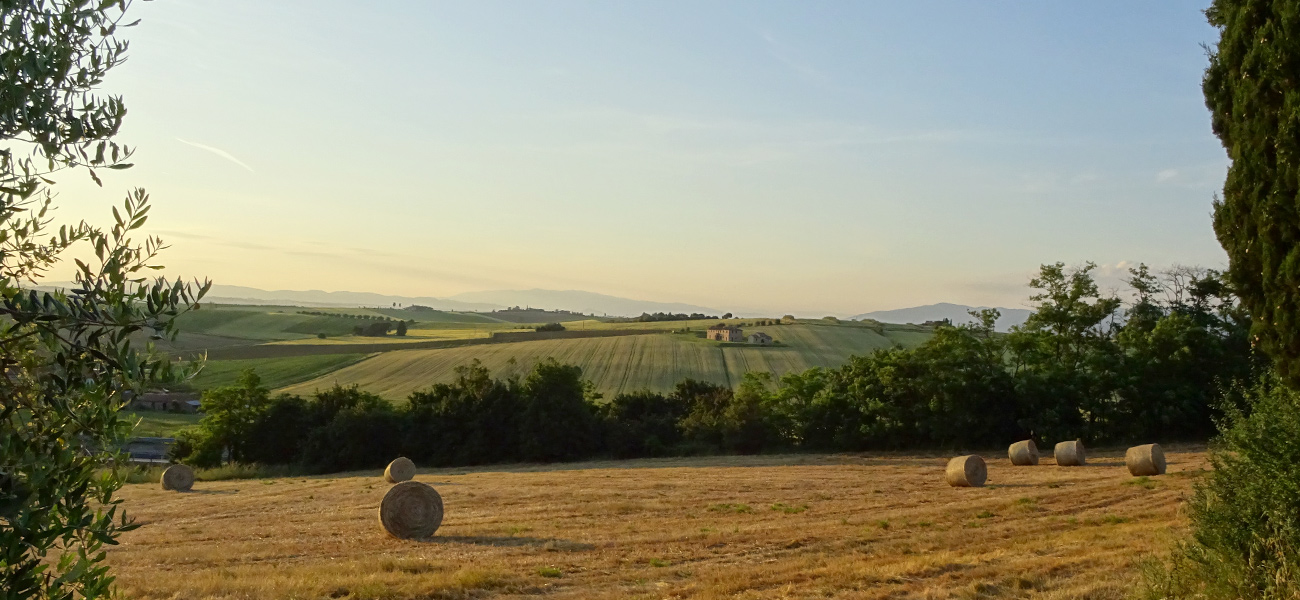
(182, 265), (1260, 470)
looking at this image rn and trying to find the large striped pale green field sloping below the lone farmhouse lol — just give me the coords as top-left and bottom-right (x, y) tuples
(276, 323), (927, 401)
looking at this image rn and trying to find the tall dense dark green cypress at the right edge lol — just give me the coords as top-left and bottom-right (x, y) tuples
(1203, 0), (1300, 383)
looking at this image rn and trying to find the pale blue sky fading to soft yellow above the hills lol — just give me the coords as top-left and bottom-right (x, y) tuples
(48, 0), (1227, 316)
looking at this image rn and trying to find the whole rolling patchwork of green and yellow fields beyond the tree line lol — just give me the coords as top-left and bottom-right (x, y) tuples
(168, 305), (931, 401)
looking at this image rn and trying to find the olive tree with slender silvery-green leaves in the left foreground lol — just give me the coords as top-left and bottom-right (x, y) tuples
(0, 0), (207, 599)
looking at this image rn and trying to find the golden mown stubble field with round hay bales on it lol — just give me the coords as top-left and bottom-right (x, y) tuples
(109, 447), (1208, 599)
